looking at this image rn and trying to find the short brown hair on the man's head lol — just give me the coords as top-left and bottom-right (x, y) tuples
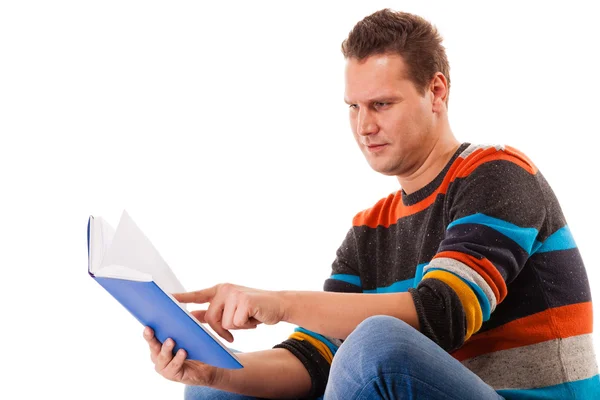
(342, 8), (450, 103)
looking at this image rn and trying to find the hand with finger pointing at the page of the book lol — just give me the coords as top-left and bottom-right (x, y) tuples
(173, 283), (285, 342)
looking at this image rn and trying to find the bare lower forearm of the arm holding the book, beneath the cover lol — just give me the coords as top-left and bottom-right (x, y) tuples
(211, 349), (311, 399)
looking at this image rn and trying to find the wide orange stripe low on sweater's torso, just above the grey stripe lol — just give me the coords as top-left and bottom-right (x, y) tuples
(452, 302), (593, 361)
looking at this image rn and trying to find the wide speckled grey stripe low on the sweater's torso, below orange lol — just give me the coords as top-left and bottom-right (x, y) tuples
(462, 334), (598, 390)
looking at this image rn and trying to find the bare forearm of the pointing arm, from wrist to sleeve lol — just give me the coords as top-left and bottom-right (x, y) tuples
(280, 291), (419, 339)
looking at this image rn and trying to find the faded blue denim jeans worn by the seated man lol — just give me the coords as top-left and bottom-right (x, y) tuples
(185, 316), (502, 400)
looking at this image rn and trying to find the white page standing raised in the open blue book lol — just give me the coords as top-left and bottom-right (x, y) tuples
(101, 211), (185, 293)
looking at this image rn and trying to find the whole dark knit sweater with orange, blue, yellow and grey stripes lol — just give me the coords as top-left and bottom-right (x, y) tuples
(275, 143), (600, 399)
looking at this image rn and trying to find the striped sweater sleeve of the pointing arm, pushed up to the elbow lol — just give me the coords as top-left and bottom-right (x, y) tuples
(410, 150), (546, 352)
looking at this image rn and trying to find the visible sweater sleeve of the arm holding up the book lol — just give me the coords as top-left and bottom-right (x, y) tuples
(274, 229), (362, 399)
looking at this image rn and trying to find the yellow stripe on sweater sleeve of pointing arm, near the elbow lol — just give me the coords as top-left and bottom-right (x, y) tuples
(423, 270), (483, 342)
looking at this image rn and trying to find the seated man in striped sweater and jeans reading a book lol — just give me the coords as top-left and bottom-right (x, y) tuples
(144, 10), (600, 400)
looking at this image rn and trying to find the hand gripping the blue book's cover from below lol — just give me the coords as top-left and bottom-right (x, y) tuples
(144, 327), (219, 386)
